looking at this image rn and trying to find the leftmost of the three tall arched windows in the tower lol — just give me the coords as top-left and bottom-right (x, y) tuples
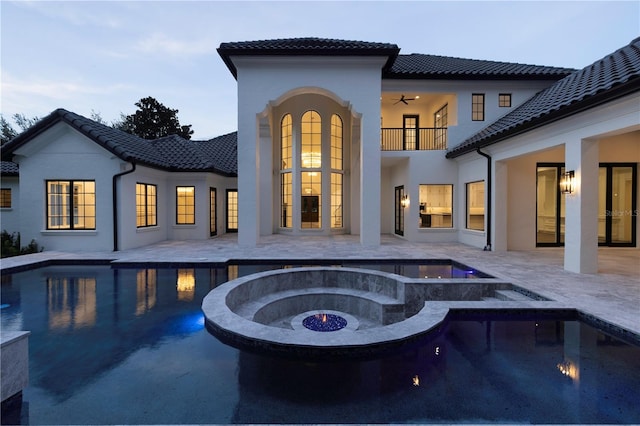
(280, 114), (293, 228)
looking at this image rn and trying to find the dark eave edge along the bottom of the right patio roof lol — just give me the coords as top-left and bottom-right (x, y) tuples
(445, 77), (640, 158)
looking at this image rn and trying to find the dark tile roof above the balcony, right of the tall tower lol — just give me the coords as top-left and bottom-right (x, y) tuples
(383, 53), (575, 80)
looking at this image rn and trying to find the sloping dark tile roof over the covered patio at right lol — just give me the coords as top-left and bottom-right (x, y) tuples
(446, 37), (640, 158)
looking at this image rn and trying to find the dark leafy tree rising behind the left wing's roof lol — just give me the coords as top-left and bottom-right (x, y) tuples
(113, 96), (193, 139)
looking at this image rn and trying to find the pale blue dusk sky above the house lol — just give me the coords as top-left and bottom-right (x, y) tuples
(0, 0), (640, 139)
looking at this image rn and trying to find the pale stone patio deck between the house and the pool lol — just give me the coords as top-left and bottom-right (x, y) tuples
(0, 234), (640, 335)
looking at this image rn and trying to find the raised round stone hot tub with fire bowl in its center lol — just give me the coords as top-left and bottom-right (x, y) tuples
(202, 267), (447, 358)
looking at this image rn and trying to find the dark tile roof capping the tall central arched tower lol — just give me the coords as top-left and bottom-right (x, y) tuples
(218, 37), (400, 78)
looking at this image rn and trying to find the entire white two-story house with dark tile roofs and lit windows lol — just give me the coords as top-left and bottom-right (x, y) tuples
(2, 38), (640, 273)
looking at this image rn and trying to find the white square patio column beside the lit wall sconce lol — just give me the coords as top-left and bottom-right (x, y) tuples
(563, 140), (598, 274)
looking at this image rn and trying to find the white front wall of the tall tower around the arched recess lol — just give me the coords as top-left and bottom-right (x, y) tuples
(232, 57), (386, 245)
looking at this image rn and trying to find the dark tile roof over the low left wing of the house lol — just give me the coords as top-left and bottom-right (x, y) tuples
(2, 109), (237, 176)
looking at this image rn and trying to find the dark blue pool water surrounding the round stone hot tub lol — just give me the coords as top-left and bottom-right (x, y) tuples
(0, 265), (640, 424)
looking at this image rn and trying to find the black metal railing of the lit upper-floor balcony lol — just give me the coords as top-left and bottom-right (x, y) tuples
(380, 127), (447, 151)
